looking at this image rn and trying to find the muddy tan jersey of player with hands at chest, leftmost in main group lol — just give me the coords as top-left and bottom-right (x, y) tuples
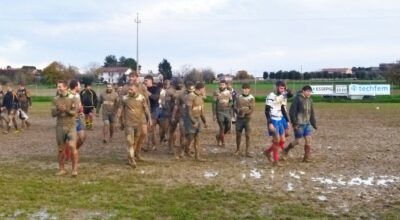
(51, 94), (78, 127)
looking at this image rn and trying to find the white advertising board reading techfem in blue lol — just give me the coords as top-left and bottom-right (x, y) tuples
(349, 84), (390, 95)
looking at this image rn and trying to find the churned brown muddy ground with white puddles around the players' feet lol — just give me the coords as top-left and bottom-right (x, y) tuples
(0, 103), (400, 217)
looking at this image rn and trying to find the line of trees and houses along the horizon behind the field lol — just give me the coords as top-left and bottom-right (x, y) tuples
(0, 55), (400, 85)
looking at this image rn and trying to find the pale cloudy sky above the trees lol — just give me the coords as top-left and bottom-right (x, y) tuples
(0, 0), (400, 76)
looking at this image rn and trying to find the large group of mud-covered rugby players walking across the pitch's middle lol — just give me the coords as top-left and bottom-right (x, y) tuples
(52, 72), (316, 177)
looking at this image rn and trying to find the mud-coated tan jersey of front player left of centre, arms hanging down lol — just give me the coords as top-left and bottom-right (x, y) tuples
(121, 94), (150, 127)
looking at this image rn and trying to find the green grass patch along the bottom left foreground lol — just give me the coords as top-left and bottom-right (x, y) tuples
(0, 164), (334, 219)
